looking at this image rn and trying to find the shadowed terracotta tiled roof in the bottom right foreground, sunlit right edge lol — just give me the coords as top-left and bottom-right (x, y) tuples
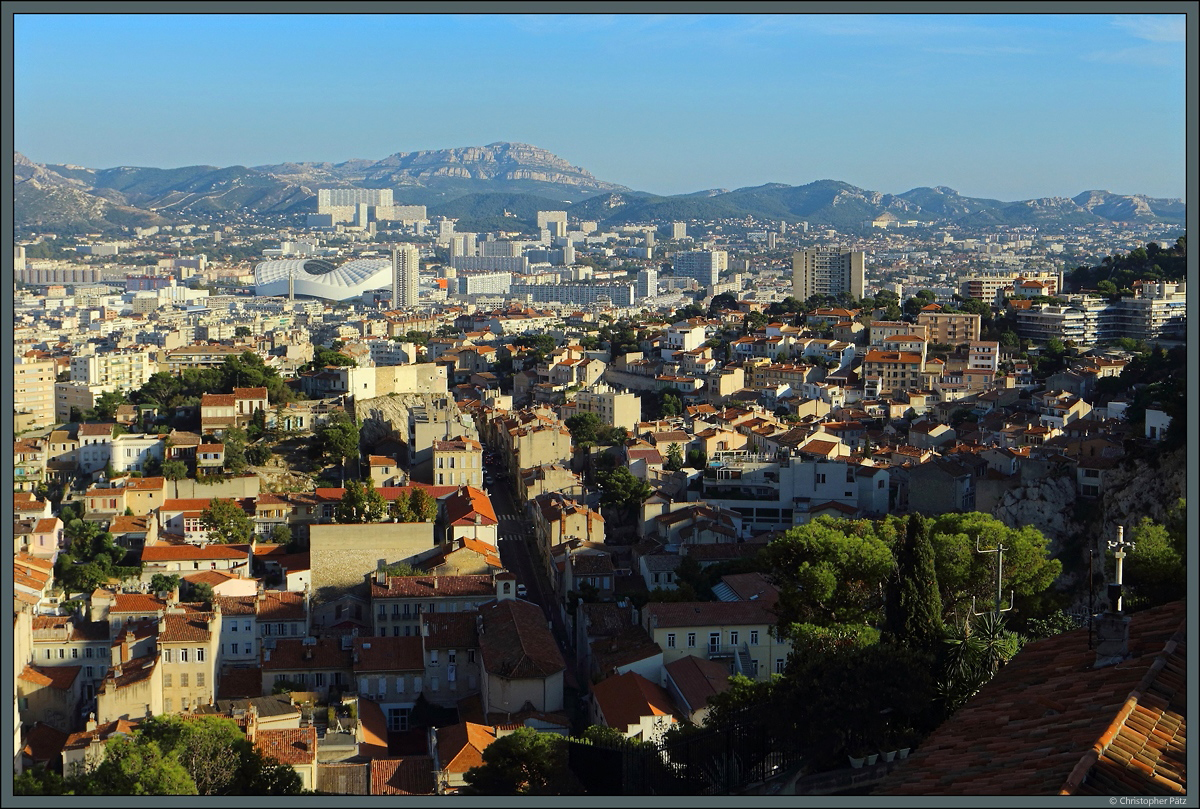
(874, 601), (1187, 796)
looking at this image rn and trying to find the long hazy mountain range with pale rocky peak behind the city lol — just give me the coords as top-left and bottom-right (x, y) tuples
(13, 143), (1187, 229)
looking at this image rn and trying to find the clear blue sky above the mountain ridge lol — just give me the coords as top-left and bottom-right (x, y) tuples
(14, 14), (1187, 199)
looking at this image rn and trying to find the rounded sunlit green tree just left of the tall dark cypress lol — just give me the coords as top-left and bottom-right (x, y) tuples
(763, 517), (894, 631)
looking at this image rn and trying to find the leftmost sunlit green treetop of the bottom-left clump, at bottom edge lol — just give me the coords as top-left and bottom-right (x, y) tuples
(74, 736), (199, 795)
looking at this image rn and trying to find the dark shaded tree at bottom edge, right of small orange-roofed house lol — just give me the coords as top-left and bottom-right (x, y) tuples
(463, 727), (569, 795)
